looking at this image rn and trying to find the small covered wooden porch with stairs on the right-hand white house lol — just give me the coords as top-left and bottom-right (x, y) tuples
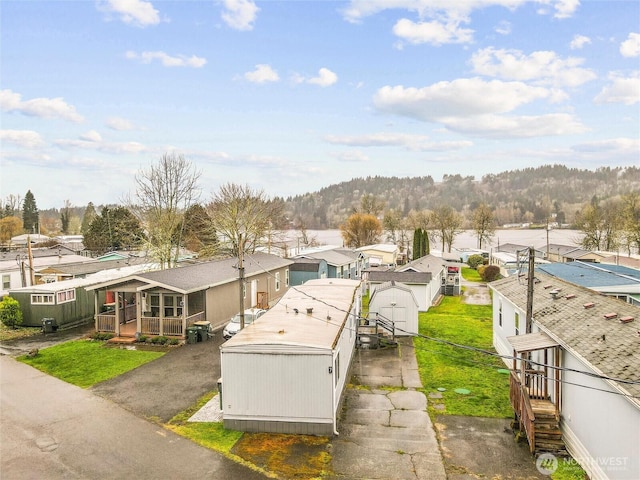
(507, 332), (566, 454)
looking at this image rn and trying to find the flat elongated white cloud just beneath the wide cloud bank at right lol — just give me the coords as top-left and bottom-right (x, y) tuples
(444, 113), (588, 138)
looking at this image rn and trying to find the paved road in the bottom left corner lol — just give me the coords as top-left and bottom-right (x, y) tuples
(0, 344), (264, 480)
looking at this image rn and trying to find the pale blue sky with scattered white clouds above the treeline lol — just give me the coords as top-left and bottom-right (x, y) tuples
(0, 0), (640, 209)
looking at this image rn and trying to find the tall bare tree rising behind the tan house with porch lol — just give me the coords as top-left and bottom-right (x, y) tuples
(131, 153), (200, 268)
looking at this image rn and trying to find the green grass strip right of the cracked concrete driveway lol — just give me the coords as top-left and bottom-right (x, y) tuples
(414, 297), (513, 418)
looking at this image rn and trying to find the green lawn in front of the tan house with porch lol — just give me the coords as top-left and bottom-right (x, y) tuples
(18, 340), (164, 388)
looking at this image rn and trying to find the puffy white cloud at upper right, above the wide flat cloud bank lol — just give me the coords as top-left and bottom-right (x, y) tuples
(471, 47), (596, 87)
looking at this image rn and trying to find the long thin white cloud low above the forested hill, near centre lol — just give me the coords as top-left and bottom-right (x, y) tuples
(325, 132), (473, 152)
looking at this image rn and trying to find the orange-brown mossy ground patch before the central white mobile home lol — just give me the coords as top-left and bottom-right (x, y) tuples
(231, 433), (331, 480)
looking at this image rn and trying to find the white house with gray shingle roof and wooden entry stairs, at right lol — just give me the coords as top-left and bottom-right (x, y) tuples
(489, 270), (640, 479)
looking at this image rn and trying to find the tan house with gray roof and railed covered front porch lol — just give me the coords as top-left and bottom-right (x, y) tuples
(89, 252), (293, 338)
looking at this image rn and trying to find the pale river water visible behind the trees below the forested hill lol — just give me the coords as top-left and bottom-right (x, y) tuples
(288, 229), (583, 251)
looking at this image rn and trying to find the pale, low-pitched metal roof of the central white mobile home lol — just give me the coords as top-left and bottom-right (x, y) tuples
(220, 278), (360, 353)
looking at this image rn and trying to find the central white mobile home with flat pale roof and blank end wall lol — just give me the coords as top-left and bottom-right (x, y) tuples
(220, 278), (361, 435)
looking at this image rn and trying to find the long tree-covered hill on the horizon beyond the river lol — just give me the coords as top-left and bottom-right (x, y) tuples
(286, 165), (640, 229)
